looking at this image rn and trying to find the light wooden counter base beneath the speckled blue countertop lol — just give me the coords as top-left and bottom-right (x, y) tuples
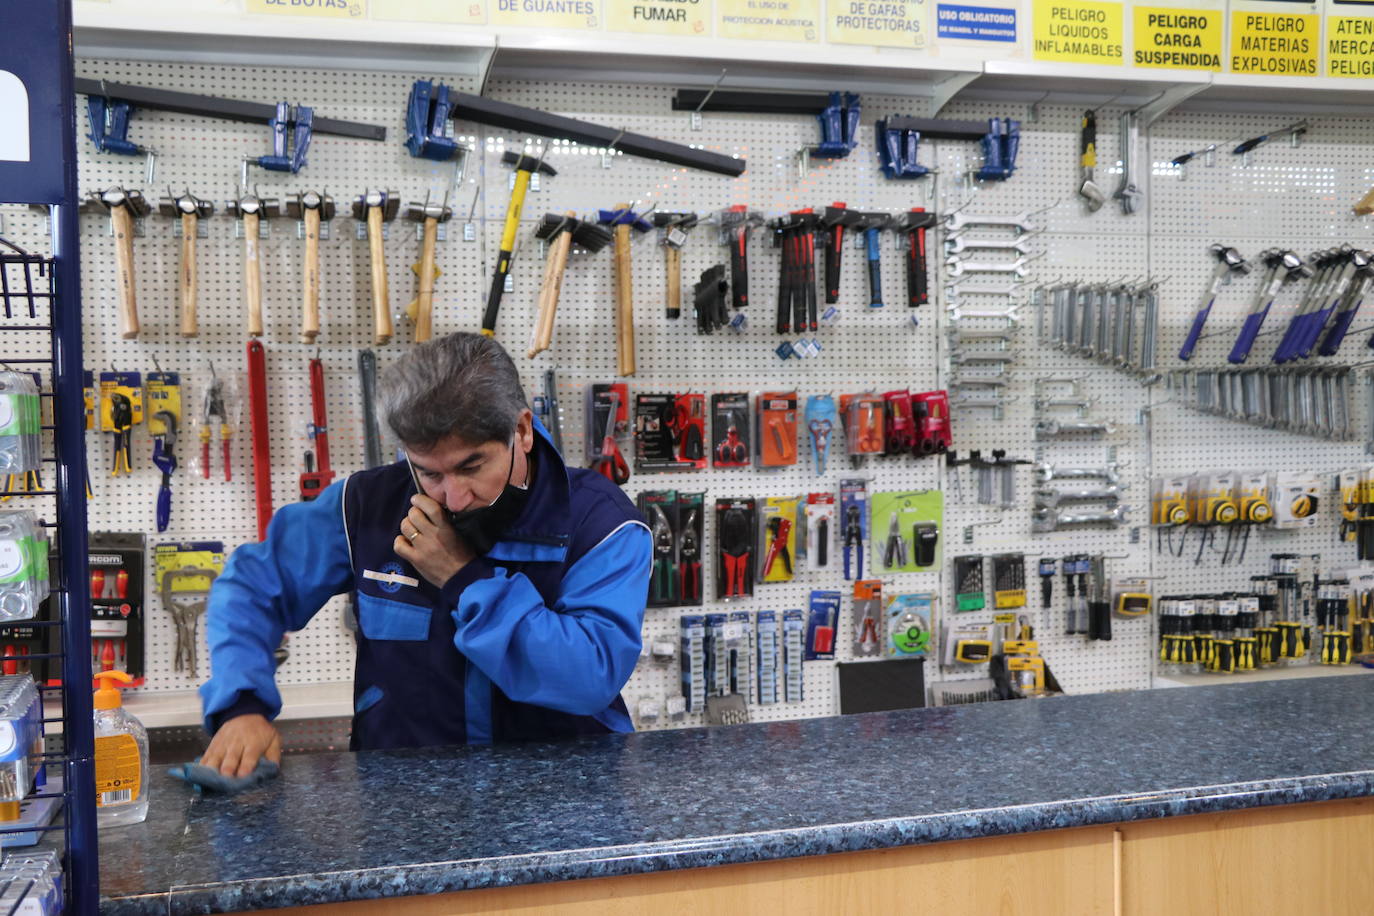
(273, 798), (1374, 916)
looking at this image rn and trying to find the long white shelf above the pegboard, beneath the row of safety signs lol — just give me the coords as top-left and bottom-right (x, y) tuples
(76, 4), (1374, 114)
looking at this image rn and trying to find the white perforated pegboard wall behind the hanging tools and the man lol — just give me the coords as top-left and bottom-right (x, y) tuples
(0, 60), (1374, 726)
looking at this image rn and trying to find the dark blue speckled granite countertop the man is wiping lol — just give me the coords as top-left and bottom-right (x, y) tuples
(100, 676), (1374, 915)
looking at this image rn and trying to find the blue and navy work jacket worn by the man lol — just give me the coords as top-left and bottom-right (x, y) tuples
(201, 424), (653, 750)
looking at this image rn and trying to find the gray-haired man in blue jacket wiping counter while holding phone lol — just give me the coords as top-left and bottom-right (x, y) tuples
(201, 334), (653, 776)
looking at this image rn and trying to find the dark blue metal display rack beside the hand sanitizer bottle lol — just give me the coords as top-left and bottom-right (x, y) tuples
(0, 0), (99, 915)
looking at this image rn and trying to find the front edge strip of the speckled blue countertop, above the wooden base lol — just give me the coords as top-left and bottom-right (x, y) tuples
(112, 770), (1374, 916)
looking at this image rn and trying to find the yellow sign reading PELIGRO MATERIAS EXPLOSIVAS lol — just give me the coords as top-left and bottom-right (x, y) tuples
(1227, 0), (1322, 77)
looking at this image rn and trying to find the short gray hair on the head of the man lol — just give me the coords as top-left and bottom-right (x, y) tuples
(381, 332), (529, 449)
